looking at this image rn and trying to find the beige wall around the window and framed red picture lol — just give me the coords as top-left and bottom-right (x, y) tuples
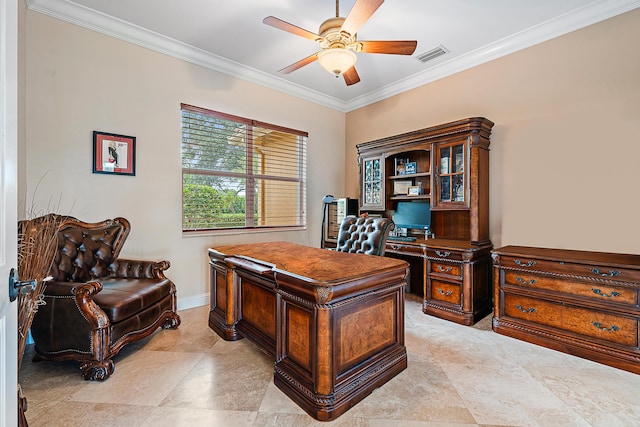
(25, 11), (345, 307)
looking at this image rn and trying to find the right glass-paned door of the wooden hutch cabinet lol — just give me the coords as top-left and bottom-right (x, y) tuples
(436, 142), (467, 206)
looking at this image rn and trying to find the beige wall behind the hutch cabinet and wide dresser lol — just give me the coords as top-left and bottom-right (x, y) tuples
(346, 9), (640, 254)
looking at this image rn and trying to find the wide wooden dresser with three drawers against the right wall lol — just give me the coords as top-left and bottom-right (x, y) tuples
(492, 246), (640, 373)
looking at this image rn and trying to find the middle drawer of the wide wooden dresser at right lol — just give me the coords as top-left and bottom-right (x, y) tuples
(504, 270), (638, 306)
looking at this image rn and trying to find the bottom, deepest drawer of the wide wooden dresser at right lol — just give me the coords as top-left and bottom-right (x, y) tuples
(504, 293), (638, 348)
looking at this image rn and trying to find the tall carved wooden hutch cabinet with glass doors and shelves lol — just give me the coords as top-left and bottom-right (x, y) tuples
(357, 117), (493, 325)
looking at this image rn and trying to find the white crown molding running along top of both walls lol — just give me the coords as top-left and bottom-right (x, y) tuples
(25, 0), (640, 113)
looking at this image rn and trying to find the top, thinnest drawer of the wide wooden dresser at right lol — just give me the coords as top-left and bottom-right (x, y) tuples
(500, 256), (640, 283)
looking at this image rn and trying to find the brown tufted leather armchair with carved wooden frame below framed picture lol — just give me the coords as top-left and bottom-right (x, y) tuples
(31, 217), (180, 380)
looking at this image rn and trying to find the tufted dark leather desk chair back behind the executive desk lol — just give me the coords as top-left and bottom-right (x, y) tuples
(336, 215), (395, 256)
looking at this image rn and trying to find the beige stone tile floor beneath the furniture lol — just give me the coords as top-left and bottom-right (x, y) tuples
(20, 295), (640, 427)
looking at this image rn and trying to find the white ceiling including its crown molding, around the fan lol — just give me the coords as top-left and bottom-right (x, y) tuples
(25, 0), (640, 111)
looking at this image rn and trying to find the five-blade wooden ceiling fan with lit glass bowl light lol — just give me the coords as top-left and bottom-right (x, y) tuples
(262, 0), (418, 86)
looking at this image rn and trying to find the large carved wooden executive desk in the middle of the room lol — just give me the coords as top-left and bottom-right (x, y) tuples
(209, 242), (408, 421)
